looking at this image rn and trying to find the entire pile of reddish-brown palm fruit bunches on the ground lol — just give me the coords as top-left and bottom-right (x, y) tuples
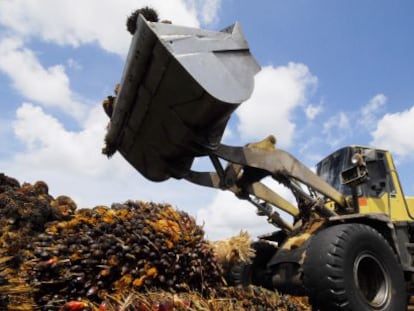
(0, 174), (308, 311)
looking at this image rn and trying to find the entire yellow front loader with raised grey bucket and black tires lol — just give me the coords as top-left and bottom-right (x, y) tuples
(104, 16), (414, 311)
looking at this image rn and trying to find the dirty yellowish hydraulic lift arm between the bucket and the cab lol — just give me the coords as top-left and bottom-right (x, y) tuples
(185, 136), (346, 230)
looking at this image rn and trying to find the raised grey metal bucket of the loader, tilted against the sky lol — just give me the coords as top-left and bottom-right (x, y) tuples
(106, 15), (259, 181)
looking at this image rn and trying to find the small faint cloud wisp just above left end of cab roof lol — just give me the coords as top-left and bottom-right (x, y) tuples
(322, 112), (351, 147)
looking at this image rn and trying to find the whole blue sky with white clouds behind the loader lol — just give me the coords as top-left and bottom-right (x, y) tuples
(0, 0), (414, 238)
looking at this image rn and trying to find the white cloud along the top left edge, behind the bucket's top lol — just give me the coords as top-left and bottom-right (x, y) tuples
(0, 0), (220, 55)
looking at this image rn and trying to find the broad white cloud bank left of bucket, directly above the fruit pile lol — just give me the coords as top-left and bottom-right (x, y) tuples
(4, 103), (217, 214)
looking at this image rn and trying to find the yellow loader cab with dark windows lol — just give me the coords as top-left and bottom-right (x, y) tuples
(316, 146), (414, 220)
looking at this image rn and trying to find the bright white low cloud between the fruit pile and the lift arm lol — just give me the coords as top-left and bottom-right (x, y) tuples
(197, 179), (294, 240)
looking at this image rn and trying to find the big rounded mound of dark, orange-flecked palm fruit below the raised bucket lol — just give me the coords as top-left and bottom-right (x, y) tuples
(31, 201), (223, 307)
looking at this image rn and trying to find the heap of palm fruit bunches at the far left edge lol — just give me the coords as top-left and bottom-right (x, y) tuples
(0, 173), (76, 310)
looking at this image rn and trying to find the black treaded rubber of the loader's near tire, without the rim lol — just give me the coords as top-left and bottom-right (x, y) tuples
(303, 224), (405, 311)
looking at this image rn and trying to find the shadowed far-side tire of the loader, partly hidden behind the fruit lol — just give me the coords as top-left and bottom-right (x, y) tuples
(226, 241), (277, 289)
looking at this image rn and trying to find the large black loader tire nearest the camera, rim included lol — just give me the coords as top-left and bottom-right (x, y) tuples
(303, 224), (407, 311)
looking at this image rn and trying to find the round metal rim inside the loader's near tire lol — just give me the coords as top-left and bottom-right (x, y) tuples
(354, 253), (391, 310)
